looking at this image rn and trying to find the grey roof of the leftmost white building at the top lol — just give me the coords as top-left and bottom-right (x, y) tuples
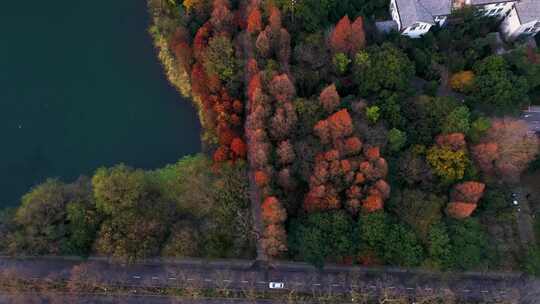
(396, 0), (452, 28)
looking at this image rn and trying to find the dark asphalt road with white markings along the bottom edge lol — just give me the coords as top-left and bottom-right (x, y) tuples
(0, 258), (540, 303)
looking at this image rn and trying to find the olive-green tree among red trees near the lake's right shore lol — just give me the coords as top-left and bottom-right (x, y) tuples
(204, 35), (235, 81)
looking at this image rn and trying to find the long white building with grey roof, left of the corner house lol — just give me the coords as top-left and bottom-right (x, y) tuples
(390, 0), (524, 38)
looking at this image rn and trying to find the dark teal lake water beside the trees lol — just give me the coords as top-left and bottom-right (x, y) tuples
(0, 0), (200, 206)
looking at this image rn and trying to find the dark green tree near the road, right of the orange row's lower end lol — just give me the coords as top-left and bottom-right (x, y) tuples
(289, 211), (355, 267)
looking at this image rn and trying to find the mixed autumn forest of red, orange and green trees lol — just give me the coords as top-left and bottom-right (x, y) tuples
(0, 0), (540, 274)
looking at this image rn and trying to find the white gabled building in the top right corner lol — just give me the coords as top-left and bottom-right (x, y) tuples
(501, 0), (540, 40)
